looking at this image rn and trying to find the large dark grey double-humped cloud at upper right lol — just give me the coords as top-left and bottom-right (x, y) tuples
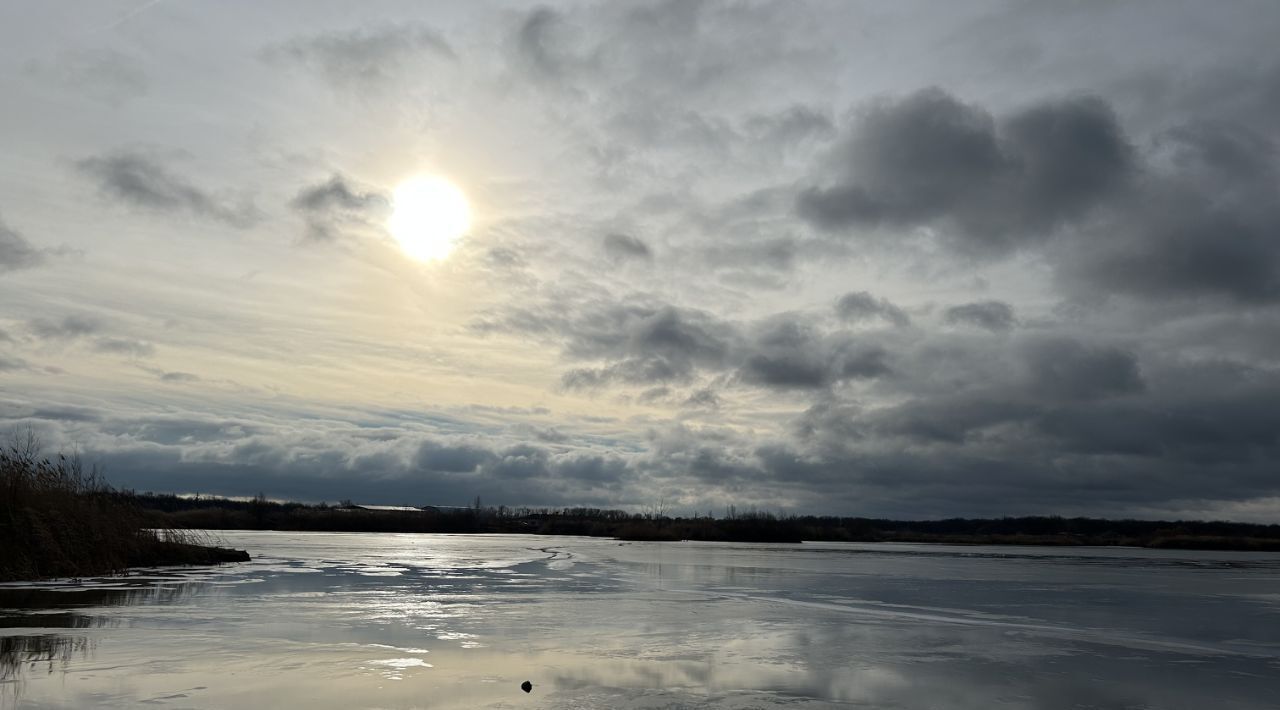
(797, 88), (1133, 253)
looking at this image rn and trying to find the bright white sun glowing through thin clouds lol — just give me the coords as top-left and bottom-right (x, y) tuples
(387, 175), (471, 261)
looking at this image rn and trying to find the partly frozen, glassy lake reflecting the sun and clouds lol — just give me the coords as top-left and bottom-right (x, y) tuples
(0, 532), (1280, 710)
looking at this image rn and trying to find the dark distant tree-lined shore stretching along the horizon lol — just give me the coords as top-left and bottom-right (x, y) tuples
(120, 493), (1280, 551)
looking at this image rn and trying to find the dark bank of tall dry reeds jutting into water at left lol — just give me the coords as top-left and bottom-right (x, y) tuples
(0, 436), (248, 581)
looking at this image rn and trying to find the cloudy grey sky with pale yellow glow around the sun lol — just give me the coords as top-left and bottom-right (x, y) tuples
(0, 0), (1280, 522)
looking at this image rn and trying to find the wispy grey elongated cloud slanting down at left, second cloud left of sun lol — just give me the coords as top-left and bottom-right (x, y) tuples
(76, 151), (261, 229)
